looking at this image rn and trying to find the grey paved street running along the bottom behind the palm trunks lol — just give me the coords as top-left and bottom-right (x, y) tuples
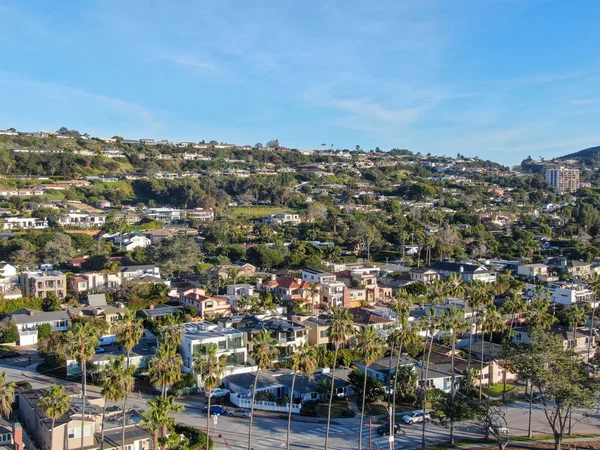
(0, 365), (600, 450)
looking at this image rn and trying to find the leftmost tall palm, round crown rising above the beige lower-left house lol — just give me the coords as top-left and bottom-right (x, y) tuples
(65, 322), (99, 450)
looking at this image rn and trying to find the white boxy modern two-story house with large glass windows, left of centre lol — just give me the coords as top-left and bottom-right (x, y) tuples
(179, 321), (248, 372)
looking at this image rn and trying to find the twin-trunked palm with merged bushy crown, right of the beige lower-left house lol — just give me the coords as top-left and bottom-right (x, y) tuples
(100, 355), (135, 449)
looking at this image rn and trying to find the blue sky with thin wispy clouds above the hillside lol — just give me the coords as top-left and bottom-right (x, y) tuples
(0, 0), (600, 164)
